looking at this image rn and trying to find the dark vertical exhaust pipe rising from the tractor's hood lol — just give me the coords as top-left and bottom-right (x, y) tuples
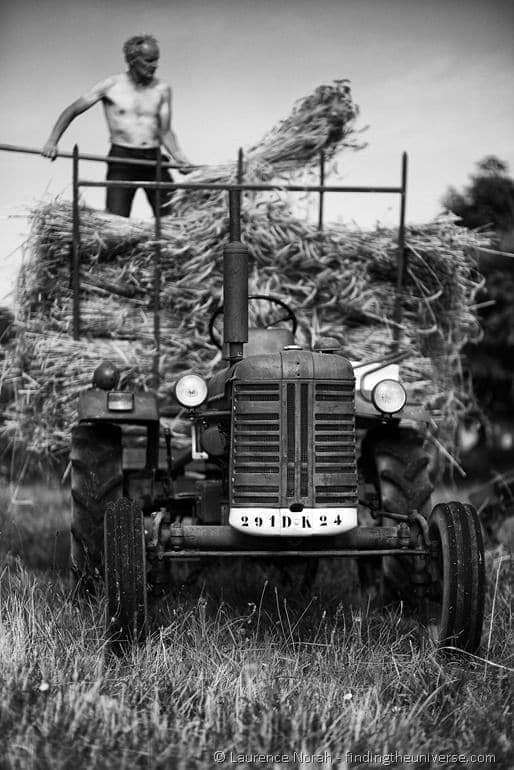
(223, 150), (248, 364)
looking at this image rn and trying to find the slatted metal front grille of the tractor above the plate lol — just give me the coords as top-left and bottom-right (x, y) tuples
(231, 380), (357, 507)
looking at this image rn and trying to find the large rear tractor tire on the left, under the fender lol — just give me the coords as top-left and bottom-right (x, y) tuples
(71, 423), (123, 594)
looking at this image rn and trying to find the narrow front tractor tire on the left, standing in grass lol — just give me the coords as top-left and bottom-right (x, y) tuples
(104, 498), (148, 652)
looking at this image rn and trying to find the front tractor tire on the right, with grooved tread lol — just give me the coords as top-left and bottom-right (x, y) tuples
(425, 503), (485, 653)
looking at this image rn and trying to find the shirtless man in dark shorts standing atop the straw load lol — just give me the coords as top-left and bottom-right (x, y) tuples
(42, 35), (191, 217)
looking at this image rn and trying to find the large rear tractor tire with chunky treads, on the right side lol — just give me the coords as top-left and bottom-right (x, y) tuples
(359, 428), (434, 610)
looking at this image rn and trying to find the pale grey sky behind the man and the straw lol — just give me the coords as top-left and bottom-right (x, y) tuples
(0, 0), (514, 302)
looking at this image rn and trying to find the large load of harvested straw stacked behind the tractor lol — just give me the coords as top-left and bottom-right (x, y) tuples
(4, 81), (480, 472)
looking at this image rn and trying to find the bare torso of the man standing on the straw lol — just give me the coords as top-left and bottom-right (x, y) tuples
(102, 73), (168, 148)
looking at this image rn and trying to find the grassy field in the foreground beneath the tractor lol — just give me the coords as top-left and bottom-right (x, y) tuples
(0, 486), (514, 770)
